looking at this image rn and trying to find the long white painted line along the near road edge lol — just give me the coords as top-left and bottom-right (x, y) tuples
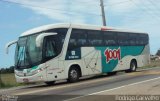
(64, 77), (160, 101)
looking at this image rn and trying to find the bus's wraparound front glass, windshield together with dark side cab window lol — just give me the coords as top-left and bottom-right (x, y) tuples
(15, 28), (67, 69)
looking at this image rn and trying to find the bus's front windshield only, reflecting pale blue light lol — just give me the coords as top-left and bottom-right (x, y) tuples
(15, 34), (42, 69)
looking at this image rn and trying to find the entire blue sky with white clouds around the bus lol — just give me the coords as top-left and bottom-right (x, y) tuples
(0, 0), (160, 68)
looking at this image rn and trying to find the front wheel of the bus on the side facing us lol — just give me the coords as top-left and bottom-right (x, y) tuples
(68, 66), (80, 83)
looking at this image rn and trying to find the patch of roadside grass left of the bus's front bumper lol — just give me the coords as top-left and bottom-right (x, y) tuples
(0, 73), (25, 89)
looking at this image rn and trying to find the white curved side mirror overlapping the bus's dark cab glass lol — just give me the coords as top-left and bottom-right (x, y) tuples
(36, 33), (57, 47)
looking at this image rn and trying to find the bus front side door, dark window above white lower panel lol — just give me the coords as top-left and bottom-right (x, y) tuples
(44, 36), (60, 80)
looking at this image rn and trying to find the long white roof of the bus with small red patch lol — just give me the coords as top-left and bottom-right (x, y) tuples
(21, 23), (148, 37)
